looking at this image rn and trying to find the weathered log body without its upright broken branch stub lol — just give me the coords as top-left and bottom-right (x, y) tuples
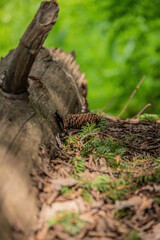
(0, 44), (87, 239)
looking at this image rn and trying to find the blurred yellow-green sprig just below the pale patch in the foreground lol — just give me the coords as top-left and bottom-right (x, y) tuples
(48, 211), (85, 235)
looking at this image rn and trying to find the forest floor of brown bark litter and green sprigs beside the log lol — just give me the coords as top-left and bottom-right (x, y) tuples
(30, 115), (160, 240)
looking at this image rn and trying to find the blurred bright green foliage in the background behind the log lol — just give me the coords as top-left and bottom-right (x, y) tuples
(0, 0), (160, 117)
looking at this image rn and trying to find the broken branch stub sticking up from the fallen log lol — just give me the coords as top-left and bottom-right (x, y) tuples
(2, 1), (59, 94)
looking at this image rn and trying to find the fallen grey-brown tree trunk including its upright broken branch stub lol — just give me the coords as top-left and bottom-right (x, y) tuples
(0, 1), (87, 240)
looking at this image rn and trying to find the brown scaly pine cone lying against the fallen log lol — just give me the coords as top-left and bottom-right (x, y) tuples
(64, 113), (101, 129)
